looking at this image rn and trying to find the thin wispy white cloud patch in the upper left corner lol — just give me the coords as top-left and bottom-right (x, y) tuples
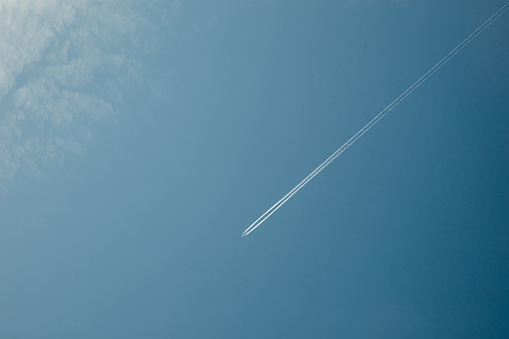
(0, 0), (146, 190)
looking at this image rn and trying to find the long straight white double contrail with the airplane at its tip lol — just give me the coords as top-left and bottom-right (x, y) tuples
(242, 2), (509, 237)
